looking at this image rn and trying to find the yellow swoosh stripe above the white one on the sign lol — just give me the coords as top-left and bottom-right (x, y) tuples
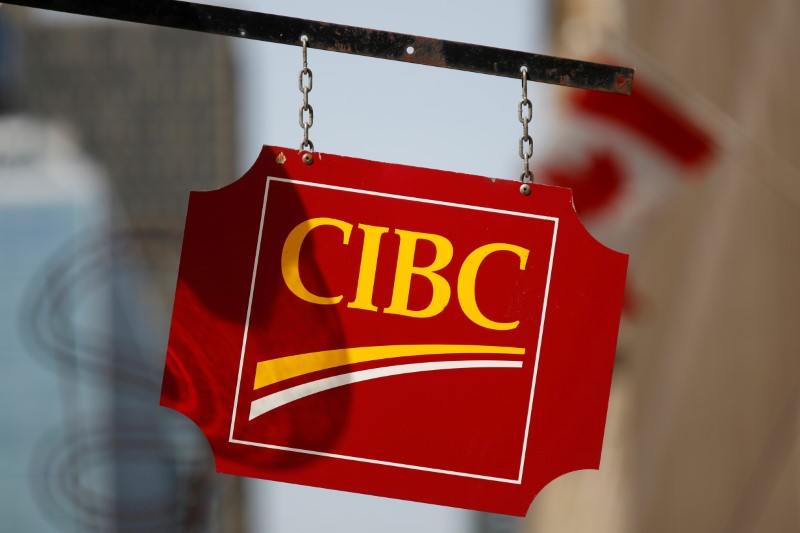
(253, 344), (525, 390)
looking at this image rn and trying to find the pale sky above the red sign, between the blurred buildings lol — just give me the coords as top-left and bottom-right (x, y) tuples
(216, 0), (555, 179)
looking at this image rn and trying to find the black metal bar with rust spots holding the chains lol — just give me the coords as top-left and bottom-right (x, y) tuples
(3, 0), (633, 94)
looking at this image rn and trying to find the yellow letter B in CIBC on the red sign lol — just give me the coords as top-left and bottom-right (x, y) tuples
(384, 229), (453, 318)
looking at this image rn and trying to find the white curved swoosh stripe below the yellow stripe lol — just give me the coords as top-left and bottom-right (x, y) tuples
(250, 360), (522, 420)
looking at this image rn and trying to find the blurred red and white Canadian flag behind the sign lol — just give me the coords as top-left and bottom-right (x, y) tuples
(537, 68), (715, 316)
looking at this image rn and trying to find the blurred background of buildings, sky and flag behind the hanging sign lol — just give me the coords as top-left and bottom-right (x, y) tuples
(0, 0), (800, 533)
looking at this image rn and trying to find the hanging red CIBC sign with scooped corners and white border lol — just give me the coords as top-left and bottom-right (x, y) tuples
(161, 147), (627, 516)
